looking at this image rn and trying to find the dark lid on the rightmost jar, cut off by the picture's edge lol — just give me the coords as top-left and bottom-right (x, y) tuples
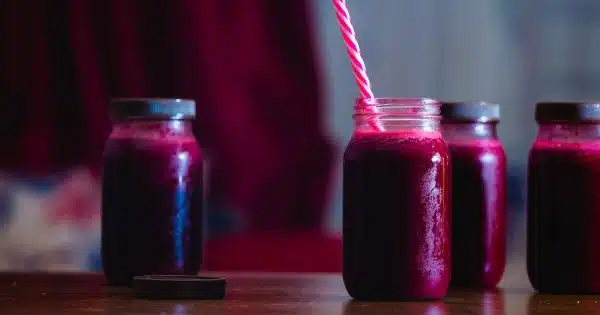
(535, 101), (600, 123)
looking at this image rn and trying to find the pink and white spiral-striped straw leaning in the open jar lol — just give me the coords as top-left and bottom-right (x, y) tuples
(333, 0), (383, 131)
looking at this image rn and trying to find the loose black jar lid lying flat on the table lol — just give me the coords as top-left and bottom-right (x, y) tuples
(133, 275), (227, 300)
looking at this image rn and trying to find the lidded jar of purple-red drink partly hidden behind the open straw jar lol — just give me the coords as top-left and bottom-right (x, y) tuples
(442, 102), (506, 288)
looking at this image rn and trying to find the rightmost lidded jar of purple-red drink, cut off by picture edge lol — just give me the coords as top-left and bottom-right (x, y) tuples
(527, 102), (600, 294)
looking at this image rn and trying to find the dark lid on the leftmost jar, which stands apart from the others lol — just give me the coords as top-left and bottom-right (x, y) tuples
(110, 98), (196, 121)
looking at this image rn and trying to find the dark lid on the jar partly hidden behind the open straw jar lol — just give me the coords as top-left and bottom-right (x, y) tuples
(441, 102), (500, 123)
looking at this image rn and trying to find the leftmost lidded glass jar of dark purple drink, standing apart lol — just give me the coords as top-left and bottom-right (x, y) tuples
(102, 99), (203, 285)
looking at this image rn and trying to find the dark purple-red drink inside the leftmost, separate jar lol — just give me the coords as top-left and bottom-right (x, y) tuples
(102, 133), (202, 284)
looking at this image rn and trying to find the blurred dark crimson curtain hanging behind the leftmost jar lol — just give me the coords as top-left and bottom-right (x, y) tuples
(0, 0), (333, 272)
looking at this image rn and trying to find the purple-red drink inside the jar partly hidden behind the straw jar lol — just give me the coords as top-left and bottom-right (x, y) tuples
(448, 139), (506, 288)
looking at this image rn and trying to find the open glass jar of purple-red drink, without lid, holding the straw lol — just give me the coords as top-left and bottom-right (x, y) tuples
(343, 98), (451, 300)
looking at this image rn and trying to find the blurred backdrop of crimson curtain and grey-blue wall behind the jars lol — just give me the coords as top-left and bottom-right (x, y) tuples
(0, 0), (600, 283)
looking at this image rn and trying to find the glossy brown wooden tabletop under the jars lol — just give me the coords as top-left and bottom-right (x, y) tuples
(0, 274), (600, 315)
